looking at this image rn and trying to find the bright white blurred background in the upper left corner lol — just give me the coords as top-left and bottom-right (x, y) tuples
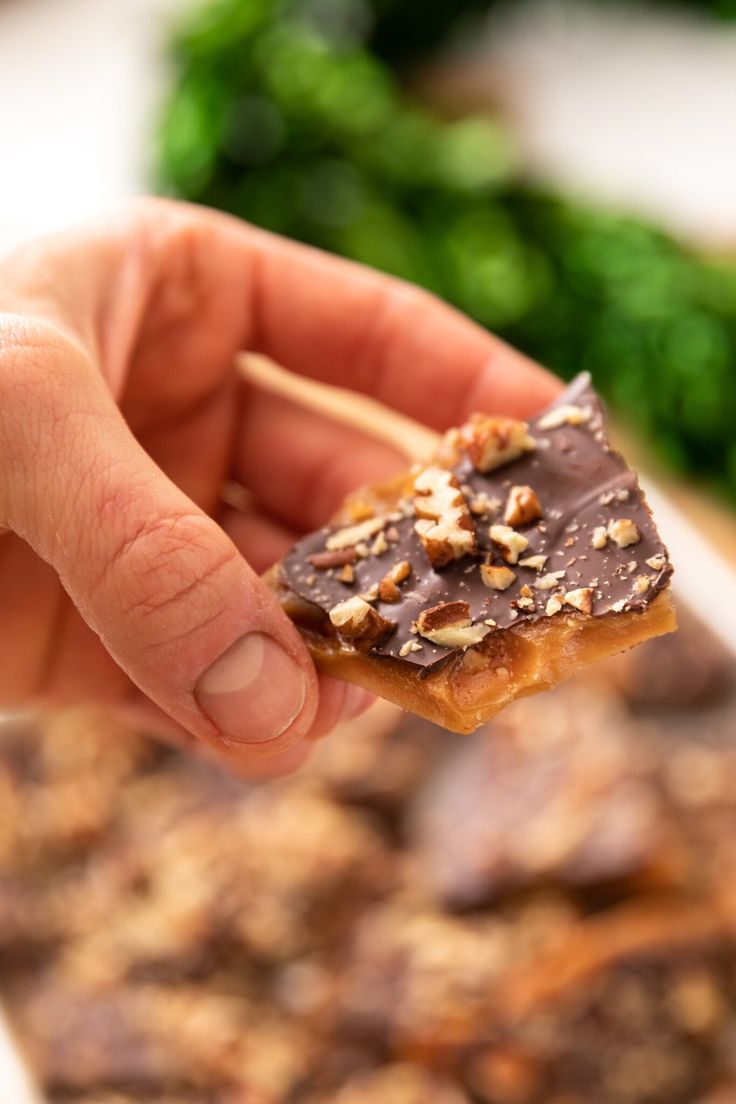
(0, 0), (183, 248)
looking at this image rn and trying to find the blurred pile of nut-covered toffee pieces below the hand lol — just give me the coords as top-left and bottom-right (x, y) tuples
(0, 609), (736, 1104)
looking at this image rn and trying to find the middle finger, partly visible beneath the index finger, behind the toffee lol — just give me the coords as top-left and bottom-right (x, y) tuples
(234, 384), (406, 531)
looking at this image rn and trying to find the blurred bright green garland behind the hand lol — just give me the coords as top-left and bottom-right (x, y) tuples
(158, 0), (736, 499)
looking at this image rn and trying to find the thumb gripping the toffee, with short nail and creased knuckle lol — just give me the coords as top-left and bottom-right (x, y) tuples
(0, 329), (318, 758)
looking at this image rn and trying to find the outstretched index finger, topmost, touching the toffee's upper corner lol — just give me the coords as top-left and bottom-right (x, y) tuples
(239, 216), (561, 429)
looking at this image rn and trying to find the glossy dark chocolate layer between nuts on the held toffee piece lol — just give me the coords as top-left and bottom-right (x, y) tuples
(281, 373), (672, 673)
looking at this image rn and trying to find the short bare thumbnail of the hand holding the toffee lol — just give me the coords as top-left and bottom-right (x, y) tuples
(194, 633), (307, 744)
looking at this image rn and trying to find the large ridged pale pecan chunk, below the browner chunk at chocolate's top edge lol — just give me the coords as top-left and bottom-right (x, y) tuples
(414, 467), (477, 567)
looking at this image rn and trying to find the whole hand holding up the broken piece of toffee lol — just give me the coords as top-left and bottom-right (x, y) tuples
(0, 200), (557, 774)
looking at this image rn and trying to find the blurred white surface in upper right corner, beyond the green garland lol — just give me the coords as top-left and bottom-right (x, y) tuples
(483, 0), (736, 246)
